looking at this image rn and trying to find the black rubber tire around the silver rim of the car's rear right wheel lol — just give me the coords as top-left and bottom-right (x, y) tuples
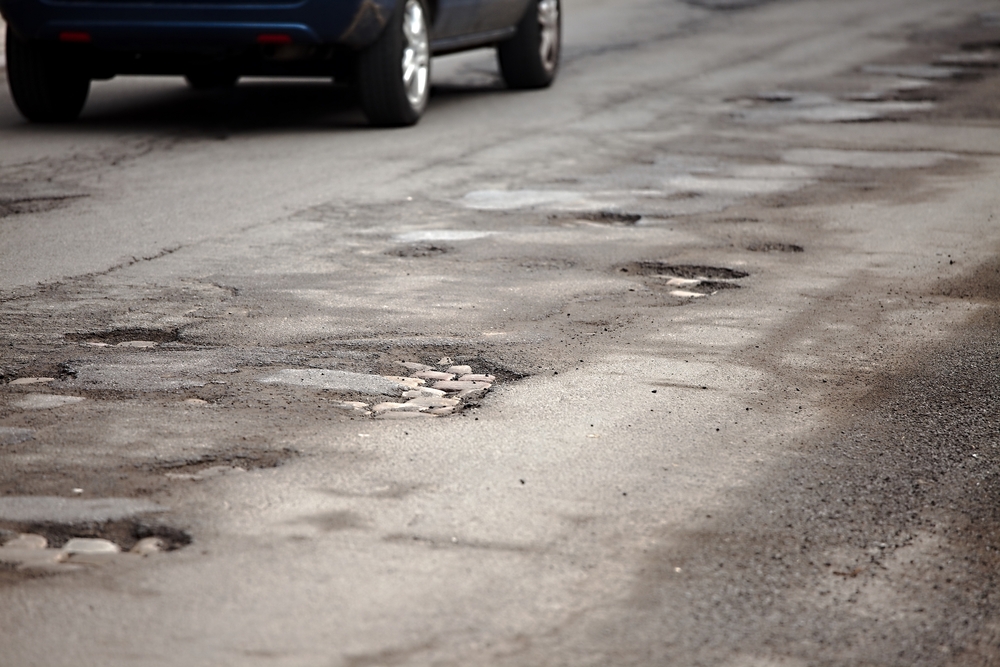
(357, 0), (430, 127)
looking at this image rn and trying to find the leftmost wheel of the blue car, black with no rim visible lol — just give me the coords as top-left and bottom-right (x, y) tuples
(7, 25), (90, 123)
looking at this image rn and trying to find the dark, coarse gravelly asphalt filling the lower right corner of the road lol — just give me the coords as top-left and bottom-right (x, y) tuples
(524, 261), (1000, 666)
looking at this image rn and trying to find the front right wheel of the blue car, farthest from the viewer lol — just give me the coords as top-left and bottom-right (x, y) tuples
(497, 0), (562, 90)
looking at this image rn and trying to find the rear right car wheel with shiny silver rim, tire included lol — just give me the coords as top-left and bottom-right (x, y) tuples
(358, 0), (431, 127)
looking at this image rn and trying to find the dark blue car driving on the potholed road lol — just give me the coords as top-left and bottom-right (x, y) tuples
(0, 0), (562, 127)
